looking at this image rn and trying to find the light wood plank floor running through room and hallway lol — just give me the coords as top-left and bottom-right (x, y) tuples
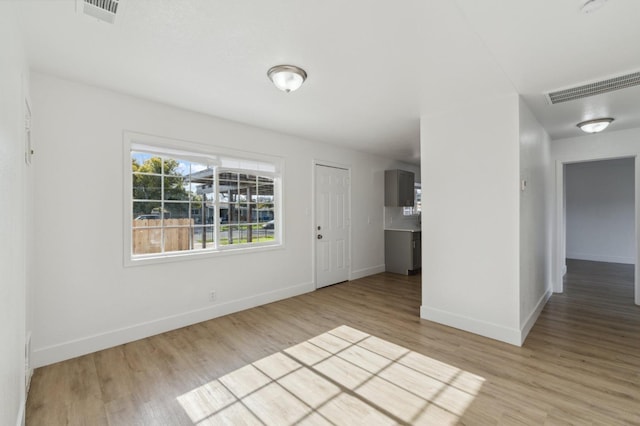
(27, 260), (640, 426)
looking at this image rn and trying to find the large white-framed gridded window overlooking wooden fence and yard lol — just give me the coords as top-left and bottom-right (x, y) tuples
(125, 134), (280, 261)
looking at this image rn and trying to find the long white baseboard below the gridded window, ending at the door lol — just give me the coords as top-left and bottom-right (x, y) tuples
(31, 282), (315, 368)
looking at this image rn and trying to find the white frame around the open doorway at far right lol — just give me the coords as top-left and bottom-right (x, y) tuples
(553, 153), (640, 305)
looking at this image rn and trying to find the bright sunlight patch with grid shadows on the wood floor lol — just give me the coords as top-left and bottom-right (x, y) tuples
(178, 325), (484, 425)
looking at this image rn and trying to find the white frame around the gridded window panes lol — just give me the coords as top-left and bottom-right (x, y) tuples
(123, 131), (284, 266)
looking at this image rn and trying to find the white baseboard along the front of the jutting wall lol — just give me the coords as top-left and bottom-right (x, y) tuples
(420, 305), (522, 346)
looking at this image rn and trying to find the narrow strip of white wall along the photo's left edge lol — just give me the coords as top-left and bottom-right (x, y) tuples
(0, 2), (29, 425)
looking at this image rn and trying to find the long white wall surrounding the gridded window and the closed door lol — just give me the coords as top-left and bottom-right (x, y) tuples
(32, 74), (415, 365)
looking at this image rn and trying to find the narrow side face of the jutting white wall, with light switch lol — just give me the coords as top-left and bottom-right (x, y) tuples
(519, 99), (553, 341)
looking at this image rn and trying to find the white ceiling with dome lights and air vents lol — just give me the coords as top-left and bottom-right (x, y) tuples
(14, 0), (640, 164)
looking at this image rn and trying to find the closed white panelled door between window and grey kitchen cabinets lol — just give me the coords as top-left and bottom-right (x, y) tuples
(315, 164), (350, 288)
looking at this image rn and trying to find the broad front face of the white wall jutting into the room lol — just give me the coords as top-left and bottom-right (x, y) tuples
(420, 93), (521, 345)
